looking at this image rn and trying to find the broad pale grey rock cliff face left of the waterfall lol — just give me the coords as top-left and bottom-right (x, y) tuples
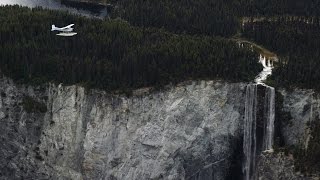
(0, 78), (246, 179)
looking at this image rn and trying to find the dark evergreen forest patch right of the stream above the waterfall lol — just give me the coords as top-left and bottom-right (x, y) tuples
(243, 17), (320, 89)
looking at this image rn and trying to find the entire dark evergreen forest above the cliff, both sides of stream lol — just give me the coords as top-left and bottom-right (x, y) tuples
(0, 0), (320, 90)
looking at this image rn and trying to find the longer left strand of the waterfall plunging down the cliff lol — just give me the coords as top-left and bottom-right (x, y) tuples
(243, 84), (258, 180)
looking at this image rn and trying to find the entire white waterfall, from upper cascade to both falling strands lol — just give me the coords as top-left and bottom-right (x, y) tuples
(243, 55), (276, 180)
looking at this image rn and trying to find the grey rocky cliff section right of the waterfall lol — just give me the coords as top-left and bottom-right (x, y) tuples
(258, 89), (320, 180)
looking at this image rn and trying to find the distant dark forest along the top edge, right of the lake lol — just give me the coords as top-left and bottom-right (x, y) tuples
(113, 0), (320, 37)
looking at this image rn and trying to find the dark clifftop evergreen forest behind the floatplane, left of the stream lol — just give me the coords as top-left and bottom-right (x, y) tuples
(0, 6), (261, 90)
